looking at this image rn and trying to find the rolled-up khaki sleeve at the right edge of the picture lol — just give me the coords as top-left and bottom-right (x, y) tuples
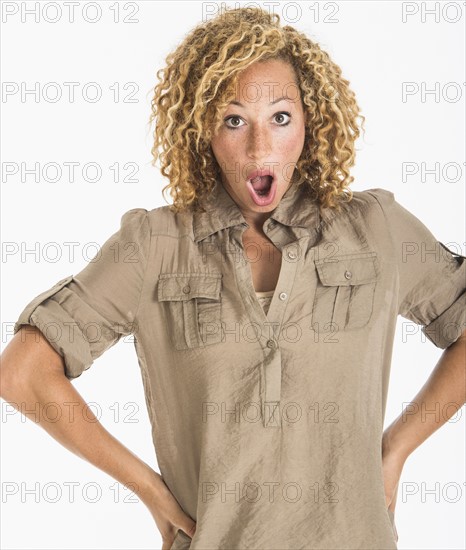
(371, 189), (466, 349)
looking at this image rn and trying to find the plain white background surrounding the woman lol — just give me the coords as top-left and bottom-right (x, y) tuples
(1, 1), (466, 549)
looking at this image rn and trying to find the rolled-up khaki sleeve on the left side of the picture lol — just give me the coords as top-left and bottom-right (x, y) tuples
(14, 208), (151, 380)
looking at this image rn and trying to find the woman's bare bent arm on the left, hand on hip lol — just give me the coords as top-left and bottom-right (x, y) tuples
(0, 325), (196, 548)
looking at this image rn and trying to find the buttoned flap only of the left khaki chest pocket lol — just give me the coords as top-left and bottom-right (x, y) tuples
(158, 273), (222, 302)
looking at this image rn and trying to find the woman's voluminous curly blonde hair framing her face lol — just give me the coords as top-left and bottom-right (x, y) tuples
(149, 6), (365, 212)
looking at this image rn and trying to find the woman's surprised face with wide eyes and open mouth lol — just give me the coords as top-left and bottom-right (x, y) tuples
(211, 59), (305, 230)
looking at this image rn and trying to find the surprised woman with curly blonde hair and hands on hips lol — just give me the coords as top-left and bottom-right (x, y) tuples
(1, 8), (466, 549)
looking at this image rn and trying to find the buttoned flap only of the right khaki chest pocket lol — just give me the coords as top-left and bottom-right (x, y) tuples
(316, 252), (377, 286)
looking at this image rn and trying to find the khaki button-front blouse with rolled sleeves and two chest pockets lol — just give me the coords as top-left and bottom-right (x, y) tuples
(15, 183), (466, 550)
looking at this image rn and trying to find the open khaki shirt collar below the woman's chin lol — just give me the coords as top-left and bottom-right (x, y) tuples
(193, 181), (320, 242)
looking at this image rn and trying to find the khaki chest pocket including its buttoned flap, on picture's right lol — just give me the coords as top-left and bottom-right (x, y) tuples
(312, 252), (378, 334)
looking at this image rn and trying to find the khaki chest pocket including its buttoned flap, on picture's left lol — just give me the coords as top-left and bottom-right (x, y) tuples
(157, 272), (222, 350)
